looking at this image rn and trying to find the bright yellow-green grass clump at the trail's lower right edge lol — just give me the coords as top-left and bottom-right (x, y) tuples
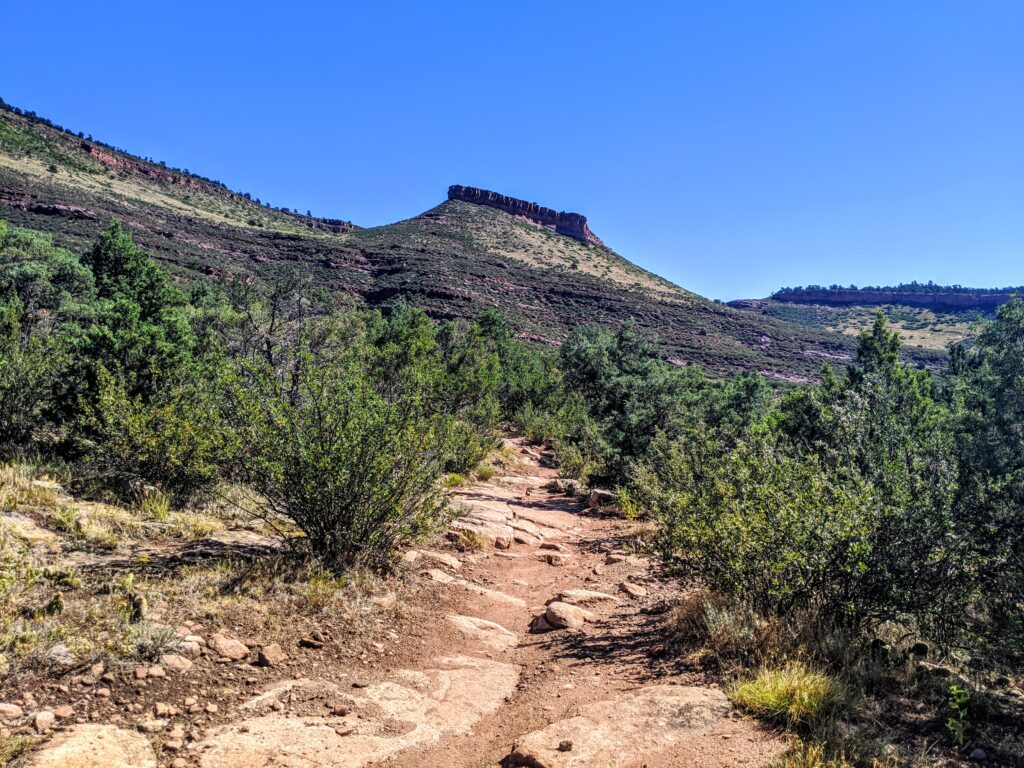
(726, 664), (844, 727)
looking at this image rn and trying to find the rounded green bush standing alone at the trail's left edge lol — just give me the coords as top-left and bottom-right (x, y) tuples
(225, 352), (454, 570)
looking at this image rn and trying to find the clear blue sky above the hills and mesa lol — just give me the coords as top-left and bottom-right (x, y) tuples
(0, 0), (1024, 299)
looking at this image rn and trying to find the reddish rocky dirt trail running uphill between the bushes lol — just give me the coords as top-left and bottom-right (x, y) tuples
(14, 440), (785, 768)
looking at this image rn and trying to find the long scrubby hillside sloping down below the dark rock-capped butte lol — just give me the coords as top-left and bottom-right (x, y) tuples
(0, 101), (880, 381)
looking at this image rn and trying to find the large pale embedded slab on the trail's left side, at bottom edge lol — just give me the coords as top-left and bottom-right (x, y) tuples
(199, 656), (519, 768)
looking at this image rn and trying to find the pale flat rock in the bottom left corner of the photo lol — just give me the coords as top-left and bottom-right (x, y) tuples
(28, 724), (157, 768)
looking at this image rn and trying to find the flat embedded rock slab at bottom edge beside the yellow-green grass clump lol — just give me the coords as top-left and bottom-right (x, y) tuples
(504, 685), (731, 768)
